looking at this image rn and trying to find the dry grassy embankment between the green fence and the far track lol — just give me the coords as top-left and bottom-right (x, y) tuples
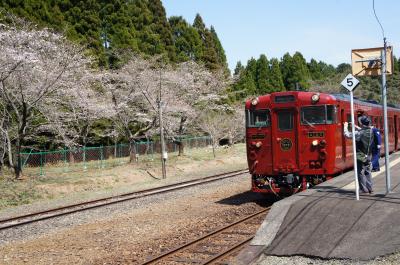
(0, 144), (247, 210)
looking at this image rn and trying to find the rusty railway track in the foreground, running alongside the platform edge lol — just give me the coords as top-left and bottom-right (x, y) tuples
(141, 207), (270, 265)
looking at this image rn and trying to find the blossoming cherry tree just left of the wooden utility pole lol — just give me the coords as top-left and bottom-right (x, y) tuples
(102, 57), (157, 162)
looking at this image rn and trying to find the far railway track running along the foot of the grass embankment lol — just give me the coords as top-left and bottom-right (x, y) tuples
(0, 169), (248, 231)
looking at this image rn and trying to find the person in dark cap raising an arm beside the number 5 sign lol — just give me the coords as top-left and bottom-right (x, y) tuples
(344, 115), (374, 193)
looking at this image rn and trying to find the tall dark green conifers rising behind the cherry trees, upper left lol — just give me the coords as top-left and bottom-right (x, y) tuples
(0, 0), (228, 72)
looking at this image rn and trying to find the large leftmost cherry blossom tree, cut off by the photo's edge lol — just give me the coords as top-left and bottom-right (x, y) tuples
(0, 21), (90, 178)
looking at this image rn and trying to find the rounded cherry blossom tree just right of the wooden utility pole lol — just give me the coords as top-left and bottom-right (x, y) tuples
(158, 62), (227, 155)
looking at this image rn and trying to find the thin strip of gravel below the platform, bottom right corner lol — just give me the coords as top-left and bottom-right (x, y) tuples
(254, 253), (400, 265)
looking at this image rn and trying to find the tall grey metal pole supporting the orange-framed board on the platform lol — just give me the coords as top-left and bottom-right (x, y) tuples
(381, 37), (390, 193)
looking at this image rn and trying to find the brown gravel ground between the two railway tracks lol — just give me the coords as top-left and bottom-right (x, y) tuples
(0, 174), (265, 264)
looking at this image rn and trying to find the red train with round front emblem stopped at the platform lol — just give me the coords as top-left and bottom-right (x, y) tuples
(246, 91), (400, 194)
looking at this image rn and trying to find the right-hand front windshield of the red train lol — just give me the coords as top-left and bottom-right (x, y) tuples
(301, 105), (336, 125)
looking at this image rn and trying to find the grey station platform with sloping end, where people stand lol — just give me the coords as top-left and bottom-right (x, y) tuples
(235, 153), (400, 264)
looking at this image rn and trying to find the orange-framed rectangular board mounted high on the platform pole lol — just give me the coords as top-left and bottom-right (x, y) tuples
(351, 46), (393, 76)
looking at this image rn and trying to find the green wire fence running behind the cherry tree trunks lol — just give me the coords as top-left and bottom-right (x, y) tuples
(20, 136), (212, 176)
